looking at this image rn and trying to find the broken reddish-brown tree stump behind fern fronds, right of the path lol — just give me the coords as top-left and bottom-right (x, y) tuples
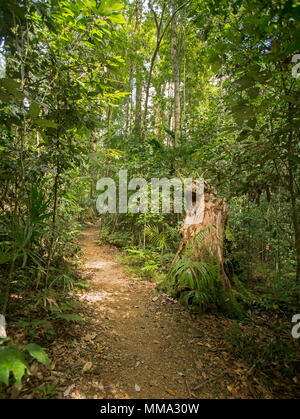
(175, 187), (230, 290)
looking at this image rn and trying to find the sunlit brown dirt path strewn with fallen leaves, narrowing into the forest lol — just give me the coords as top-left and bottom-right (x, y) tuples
(58, 226), (251, 399)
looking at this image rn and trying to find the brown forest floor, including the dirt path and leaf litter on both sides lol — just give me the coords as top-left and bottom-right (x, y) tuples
(5, 224), (296, 399)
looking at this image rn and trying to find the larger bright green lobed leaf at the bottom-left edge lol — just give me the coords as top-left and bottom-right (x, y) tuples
(0, 347), (30, 388)
